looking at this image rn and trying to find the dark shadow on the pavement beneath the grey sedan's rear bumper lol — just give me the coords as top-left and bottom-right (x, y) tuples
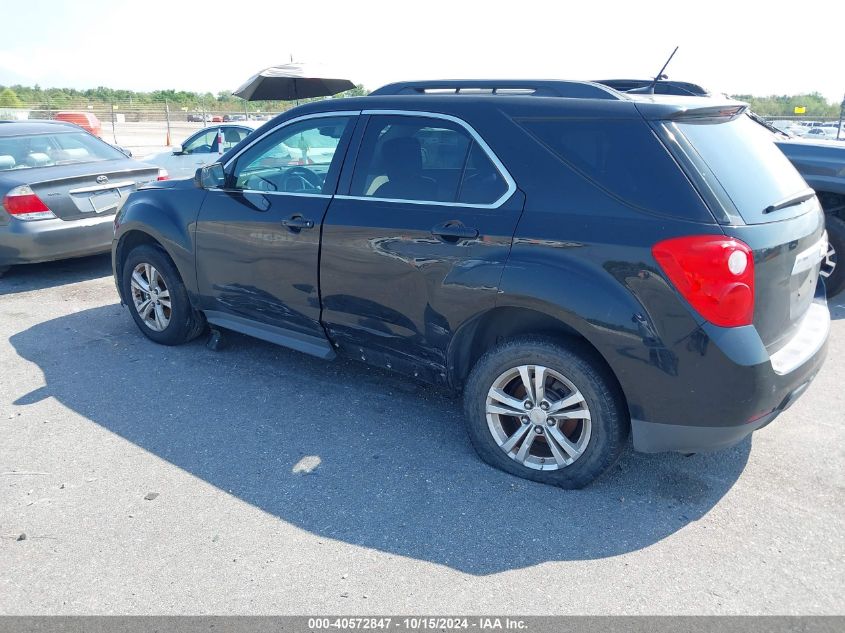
(0, 253), (112, 296)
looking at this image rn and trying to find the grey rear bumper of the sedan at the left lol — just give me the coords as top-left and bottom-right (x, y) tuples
(0, 215), (114, 266)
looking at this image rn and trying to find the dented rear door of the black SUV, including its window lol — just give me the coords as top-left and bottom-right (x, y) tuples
(320, 112), (523, 382)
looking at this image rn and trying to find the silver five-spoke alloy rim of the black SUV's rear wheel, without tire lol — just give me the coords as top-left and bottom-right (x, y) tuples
(486, 365), (591, 470)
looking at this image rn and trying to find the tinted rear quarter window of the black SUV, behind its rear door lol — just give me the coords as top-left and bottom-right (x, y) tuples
(517, 118), (709, 220)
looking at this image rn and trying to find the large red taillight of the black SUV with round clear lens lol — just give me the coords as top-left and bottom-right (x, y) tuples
(651, 235), (754, 327)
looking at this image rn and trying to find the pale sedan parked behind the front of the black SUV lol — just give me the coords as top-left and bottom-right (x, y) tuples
(143, 124), (254, 178)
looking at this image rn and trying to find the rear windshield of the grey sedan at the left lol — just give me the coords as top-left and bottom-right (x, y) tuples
(0, 132), (126, 171)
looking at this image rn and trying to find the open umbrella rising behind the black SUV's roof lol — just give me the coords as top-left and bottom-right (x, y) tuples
(232, 64), (355, 101)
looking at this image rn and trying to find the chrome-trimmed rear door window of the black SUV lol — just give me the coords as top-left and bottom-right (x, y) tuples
(350, 115), (508, 205)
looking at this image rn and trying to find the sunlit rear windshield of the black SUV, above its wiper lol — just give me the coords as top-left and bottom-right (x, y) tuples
(672, 116), (808, 224)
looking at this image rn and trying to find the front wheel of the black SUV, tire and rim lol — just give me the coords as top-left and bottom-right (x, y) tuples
(121, 244), (205, 345)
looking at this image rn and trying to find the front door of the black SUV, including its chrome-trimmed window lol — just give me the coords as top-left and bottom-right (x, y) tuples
(196, 113), (356, 356)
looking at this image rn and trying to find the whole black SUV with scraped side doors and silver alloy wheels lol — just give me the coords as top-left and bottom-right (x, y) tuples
(112, 81), (830, 487)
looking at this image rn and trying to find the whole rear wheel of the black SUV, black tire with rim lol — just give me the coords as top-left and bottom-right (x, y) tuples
(464, 336), (630, 489)
